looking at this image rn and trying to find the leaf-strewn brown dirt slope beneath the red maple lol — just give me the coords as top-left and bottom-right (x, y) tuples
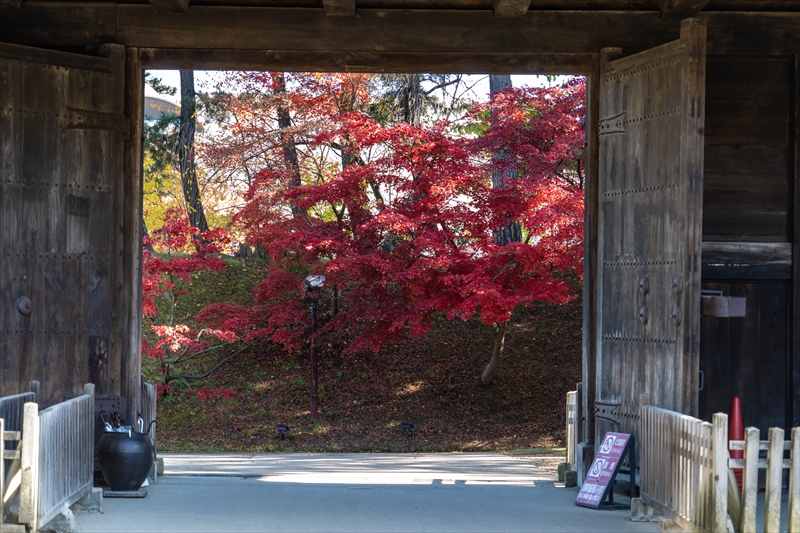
(145, 300), (581, 454)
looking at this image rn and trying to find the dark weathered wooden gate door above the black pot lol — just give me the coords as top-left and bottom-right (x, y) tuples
(0, 44), (128, 405)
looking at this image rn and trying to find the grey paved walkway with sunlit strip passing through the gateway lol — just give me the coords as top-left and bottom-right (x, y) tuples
(75, 454), (658, 533)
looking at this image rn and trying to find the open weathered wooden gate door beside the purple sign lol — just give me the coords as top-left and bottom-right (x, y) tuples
(594, 19), (706, 442)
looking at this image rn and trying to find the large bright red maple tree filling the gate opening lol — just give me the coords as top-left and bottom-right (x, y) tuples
(188, 73), (585, 382)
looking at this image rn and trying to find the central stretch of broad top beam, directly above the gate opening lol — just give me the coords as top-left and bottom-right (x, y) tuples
(117, 4), (680, 54)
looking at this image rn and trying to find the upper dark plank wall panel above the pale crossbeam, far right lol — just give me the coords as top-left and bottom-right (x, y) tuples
(703, 56), (794, 242)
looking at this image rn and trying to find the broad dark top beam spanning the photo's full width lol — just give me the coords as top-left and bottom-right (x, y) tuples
(0, 2), (800, 55)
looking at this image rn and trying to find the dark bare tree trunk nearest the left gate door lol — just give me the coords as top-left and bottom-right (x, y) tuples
(178, 70), (208, 233)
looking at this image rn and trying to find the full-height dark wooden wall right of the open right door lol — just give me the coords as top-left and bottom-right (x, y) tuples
(700, 56), (800, 438)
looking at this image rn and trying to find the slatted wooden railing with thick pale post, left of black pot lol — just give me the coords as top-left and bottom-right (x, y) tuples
(19, 384), (94, 531)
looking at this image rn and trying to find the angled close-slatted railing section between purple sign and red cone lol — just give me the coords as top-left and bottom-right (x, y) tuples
(639, 405), (726, 531)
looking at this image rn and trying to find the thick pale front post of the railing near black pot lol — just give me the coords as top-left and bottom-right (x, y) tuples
(19, 402), (39, 531)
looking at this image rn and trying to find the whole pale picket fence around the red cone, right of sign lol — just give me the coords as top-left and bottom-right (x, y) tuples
(639, 405), (800, 533)
